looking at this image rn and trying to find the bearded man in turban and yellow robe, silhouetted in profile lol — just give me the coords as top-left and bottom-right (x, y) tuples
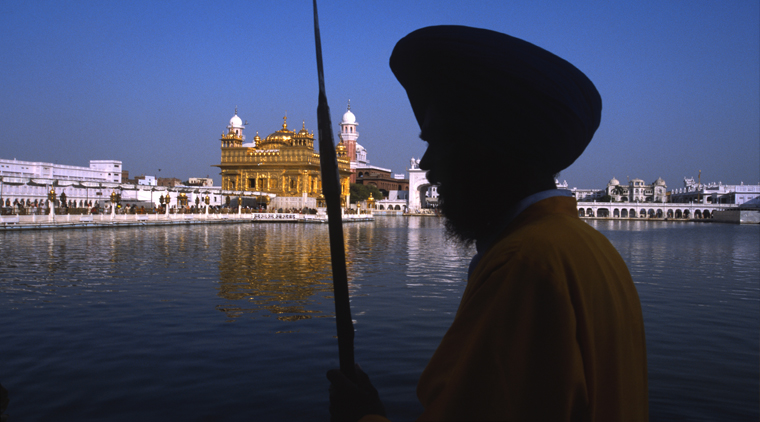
(328, 26), (648, 421)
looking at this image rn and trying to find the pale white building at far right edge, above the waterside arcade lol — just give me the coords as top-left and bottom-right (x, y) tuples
(670, 177), (760, 205)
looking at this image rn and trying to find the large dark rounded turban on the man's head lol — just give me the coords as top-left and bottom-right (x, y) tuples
(390, 26), (602, 173)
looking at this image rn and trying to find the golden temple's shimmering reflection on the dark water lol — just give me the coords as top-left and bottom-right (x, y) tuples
(217, 223), (340, 321)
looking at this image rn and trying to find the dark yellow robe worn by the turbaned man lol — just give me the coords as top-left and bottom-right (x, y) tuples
(363, 197), (649, 422)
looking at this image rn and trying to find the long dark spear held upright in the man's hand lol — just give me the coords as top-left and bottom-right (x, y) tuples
(314, 0), (356, 381)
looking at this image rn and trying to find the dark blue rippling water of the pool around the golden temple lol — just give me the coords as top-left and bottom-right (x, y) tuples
(0, 217), (760, 421)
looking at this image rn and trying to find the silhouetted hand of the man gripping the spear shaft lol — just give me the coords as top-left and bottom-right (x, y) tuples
(327, 365), (385, 422)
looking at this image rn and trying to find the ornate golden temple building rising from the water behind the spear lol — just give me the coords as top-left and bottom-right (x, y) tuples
(216, 109), (350, 209)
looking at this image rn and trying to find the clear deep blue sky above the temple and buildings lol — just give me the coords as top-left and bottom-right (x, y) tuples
(0, 0), (760, 188)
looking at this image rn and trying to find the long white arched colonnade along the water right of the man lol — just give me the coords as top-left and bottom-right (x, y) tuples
(577, 202), (738, 220)
